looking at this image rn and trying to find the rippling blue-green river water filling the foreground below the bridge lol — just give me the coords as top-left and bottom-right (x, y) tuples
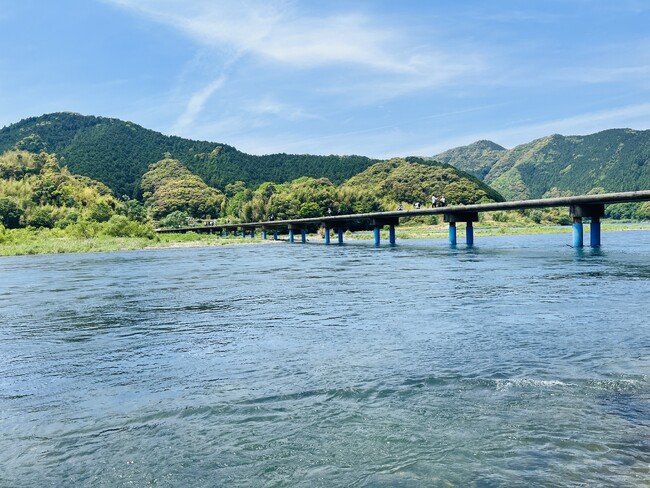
(0, 231), (650, 487)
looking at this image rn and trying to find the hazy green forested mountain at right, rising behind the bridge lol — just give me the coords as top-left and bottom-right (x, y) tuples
(432, 129), (650, 199)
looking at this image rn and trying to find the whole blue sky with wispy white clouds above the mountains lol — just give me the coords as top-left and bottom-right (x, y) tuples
(0, 0), (650, 158)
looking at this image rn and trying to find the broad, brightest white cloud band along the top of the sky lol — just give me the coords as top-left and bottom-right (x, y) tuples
(106, 0), (478, 83)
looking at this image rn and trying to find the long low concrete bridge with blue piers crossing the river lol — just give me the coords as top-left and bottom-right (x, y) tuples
(157, 190), (650, 247)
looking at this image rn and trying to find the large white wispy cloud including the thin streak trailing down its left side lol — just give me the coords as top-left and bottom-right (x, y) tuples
(103, 0), (486, 139)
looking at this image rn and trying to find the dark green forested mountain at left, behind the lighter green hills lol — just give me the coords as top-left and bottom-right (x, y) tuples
(0, 113), (377, 196)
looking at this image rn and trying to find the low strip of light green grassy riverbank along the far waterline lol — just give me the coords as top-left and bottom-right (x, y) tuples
(0, 222), (650, 256)
